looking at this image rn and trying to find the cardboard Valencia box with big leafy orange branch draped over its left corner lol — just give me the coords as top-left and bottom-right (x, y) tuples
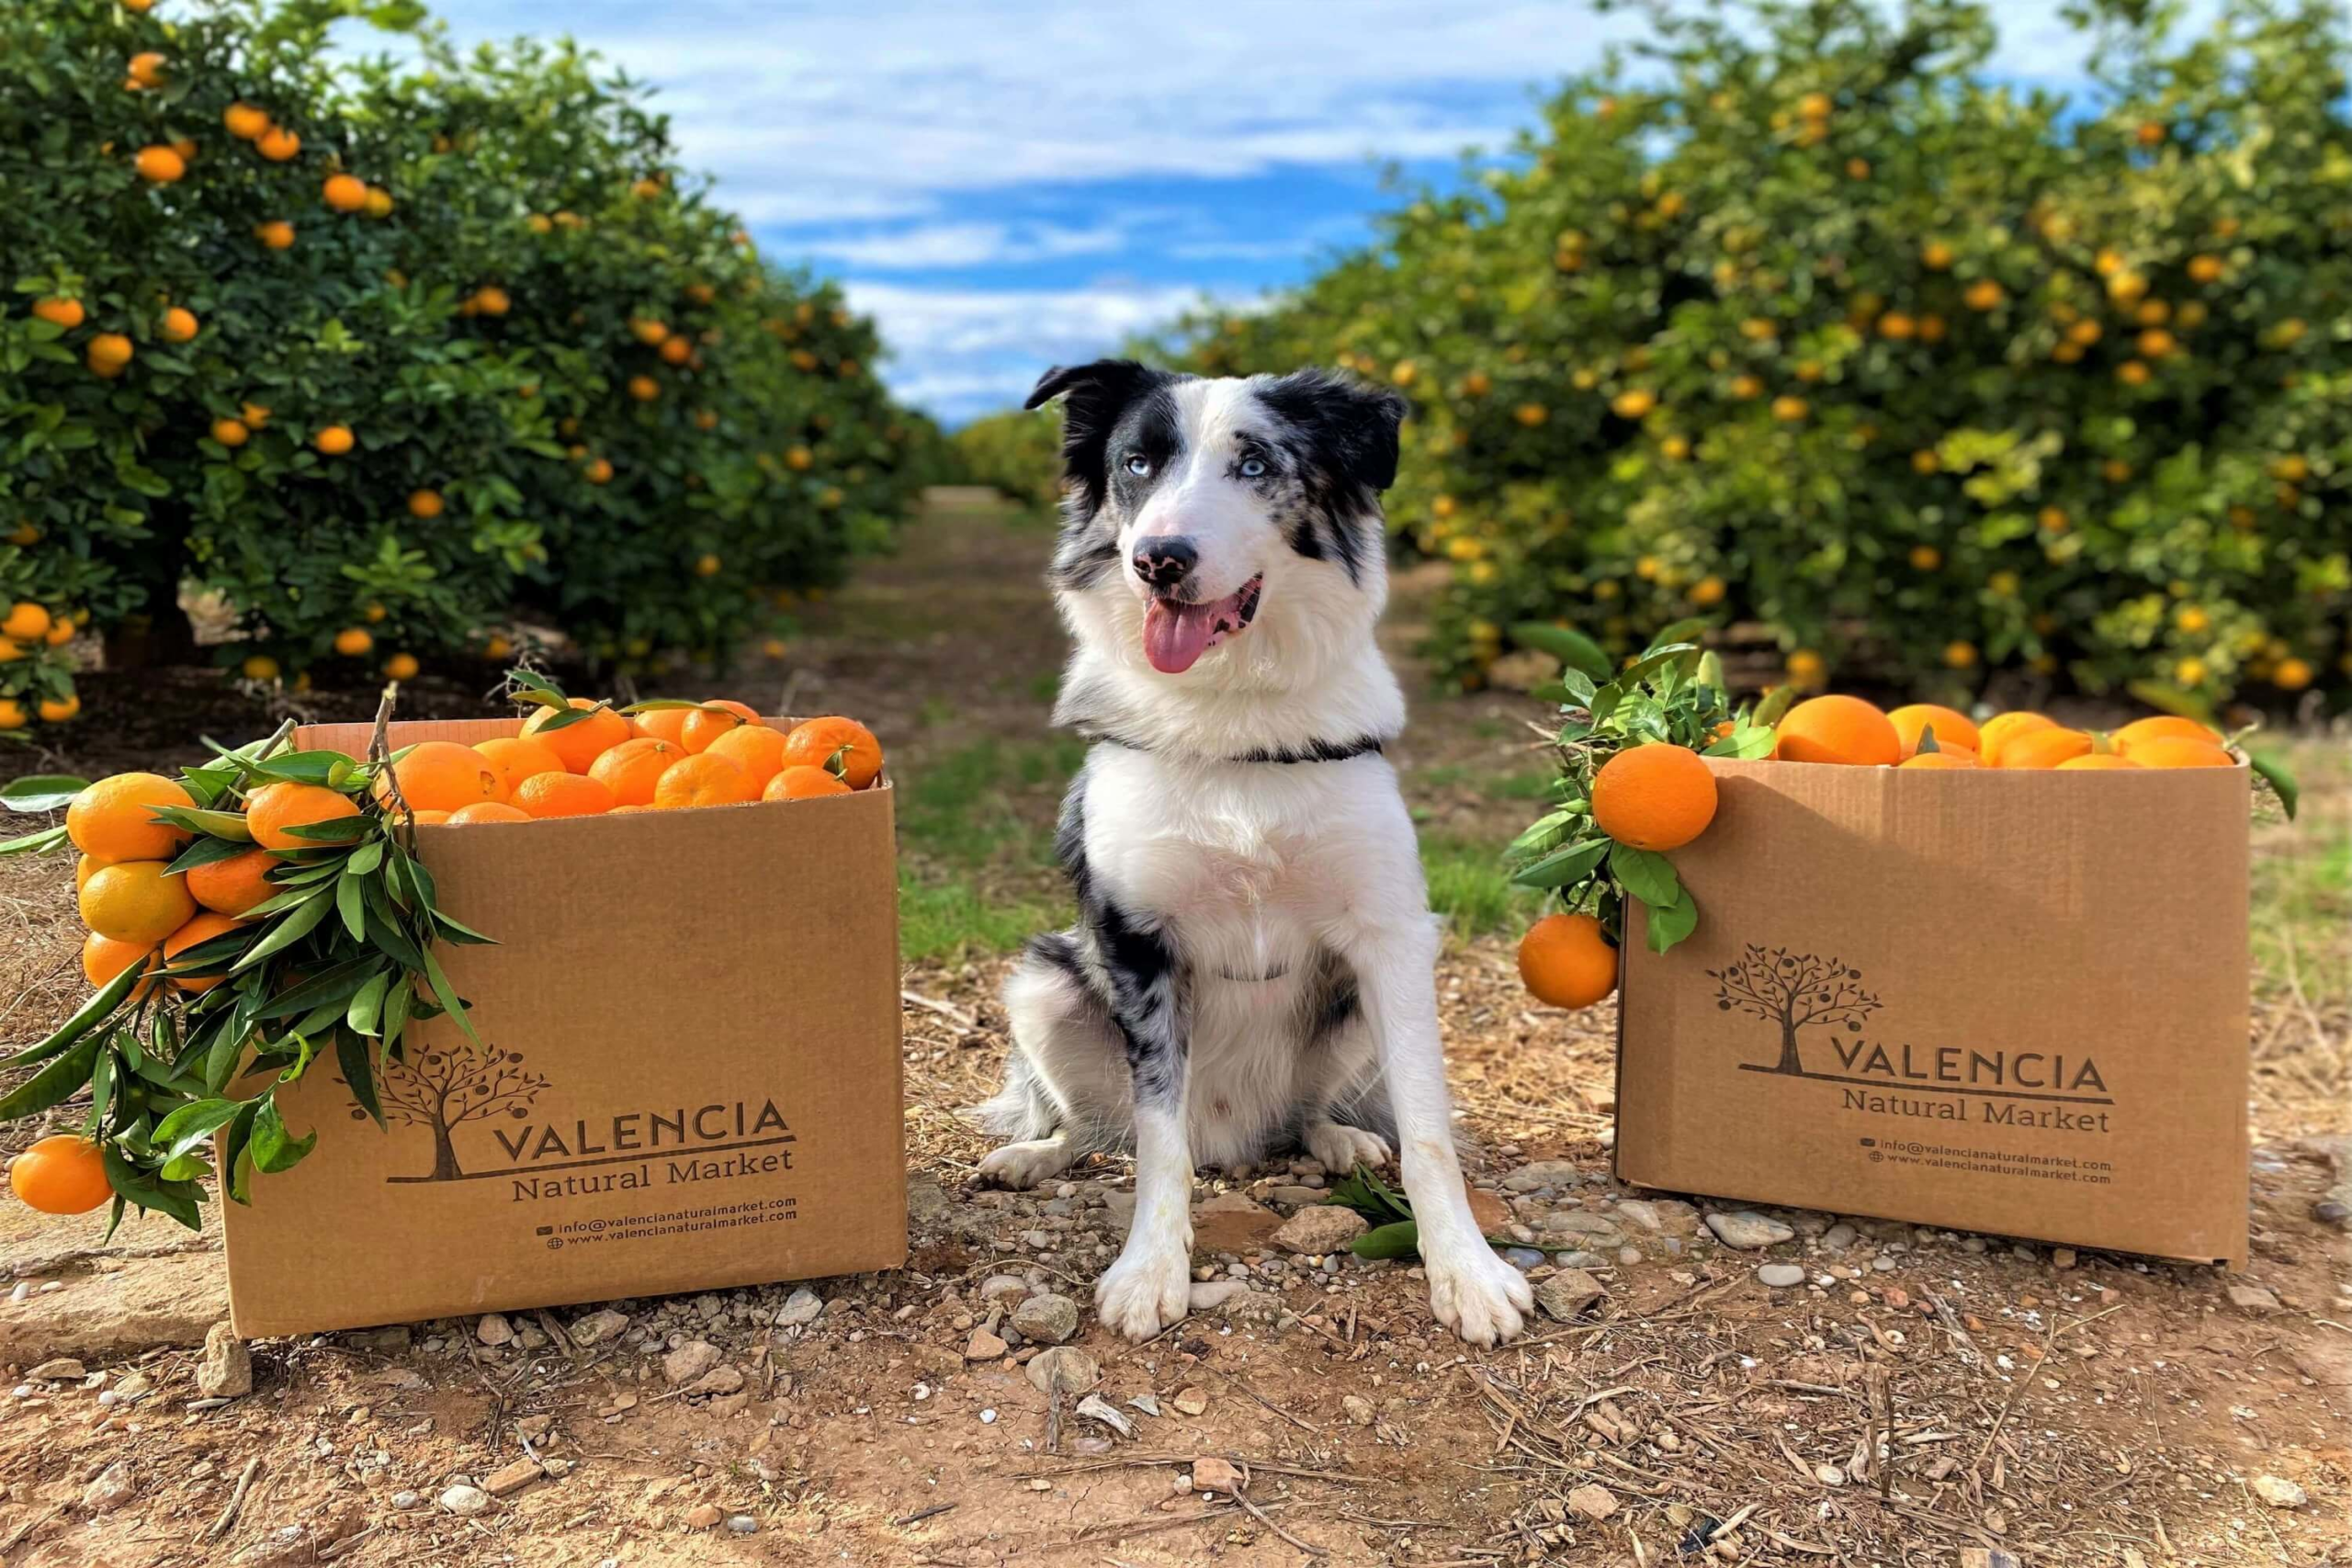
(221, 719), (906, 1336)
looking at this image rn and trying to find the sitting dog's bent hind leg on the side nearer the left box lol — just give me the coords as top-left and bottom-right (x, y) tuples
(974, 931), (1126, 1187)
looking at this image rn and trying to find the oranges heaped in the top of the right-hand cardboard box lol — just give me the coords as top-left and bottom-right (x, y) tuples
(1773, 696), (2237, 773)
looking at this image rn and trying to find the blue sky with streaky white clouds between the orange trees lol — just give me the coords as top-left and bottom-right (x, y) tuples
(409, 0), (2209, 423)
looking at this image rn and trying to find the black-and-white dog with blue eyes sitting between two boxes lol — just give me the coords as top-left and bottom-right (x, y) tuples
(981, 360), (1532, 1345)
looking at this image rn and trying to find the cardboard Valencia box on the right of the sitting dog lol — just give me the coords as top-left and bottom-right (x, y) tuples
(1616, 760), (2248, 1265)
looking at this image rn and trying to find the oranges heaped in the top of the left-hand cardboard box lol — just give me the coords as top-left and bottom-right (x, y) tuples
(379, 698), (882, 825)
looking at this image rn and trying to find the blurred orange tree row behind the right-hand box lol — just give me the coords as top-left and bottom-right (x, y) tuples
(1148, 0), (2352, 703)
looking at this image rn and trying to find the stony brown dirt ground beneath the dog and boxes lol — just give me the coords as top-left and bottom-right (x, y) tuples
(0, 493), (2352, 1568)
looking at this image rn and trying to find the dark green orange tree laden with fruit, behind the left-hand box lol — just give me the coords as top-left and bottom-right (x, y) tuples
(0, 0), (936, 719)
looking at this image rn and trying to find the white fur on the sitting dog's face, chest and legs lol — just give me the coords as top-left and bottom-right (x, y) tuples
(981, 381), (1532, 1345)
